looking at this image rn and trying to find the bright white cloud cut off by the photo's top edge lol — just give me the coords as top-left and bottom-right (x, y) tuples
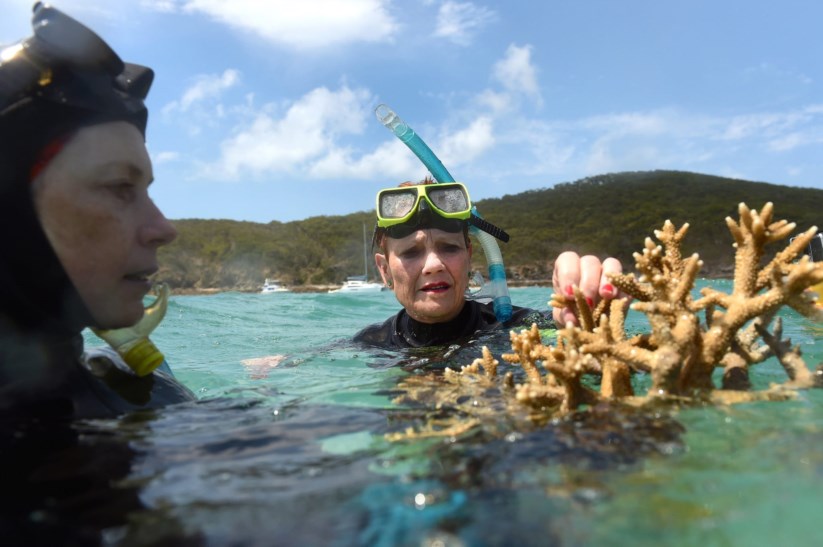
(170, 0), (398, 49)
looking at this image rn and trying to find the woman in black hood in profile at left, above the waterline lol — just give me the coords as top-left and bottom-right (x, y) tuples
(0, 2), (194, 425)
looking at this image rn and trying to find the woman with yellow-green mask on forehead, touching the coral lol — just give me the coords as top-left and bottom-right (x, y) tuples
(354, 180), (621, 348)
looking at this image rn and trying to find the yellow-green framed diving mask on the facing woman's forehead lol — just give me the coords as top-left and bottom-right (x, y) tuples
(377, 183), (471, 228)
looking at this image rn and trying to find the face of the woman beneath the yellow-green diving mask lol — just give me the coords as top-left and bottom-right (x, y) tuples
(374, 229), (471, 323)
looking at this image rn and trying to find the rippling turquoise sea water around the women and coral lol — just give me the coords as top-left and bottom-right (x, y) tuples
(74, 288), (823, 546)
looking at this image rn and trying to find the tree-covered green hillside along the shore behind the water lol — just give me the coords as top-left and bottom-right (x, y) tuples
(159, 171), (823, 290)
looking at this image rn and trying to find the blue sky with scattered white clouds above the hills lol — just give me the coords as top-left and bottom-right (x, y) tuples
(0, 0), (823, 222)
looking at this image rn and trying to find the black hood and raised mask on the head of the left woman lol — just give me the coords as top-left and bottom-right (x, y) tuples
(0, 2), (154, 332)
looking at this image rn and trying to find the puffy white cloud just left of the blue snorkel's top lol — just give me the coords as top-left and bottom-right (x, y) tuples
(208, 86), (370, 179)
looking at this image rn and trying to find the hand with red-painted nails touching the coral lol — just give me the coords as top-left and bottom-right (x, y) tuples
(552, 251), (626, 326)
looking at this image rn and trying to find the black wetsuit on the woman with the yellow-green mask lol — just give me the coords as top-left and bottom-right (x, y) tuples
(354, 300), (554, 348)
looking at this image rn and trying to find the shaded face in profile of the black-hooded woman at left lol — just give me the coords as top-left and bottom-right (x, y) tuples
(33, 122), (177, 329)
